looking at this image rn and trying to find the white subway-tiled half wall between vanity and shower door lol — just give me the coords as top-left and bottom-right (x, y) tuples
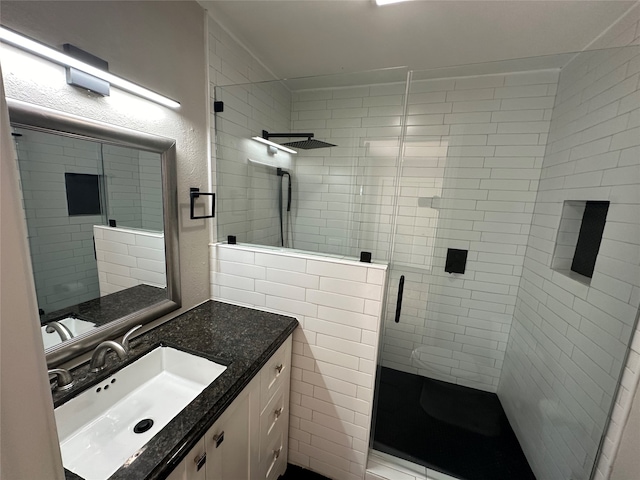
(210, 244), (386, 480)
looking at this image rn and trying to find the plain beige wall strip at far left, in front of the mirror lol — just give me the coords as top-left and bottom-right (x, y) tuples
(0, 70), (64, 480)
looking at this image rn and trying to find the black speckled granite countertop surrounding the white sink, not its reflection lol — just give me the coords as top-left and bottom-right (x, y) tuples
(54, 300), (298, 480)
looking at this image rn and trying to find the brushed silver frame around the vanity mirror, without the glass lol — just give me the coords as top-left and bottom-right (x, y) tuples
(7, 98), (182, 367)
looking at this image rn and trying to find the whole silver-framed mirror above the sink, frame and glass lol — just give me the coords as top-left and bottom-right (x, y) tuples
(7, 99), (181, 367)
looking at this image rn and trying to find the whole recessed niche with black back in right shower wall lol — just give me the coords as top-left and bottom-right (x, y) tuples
(551, 200), (609, 285)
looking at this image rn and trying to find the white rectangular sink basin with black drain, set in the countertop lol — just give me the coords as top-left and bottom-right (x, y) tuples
(55, 347), (227, 480)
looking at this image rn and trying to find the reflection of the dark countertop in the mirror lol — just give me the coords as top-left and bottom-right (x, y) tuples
(40, 284), (167, 327)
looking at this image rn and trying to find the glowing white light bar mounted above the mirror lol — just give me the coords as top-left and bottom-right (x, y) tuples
(0, 26), (180, 108)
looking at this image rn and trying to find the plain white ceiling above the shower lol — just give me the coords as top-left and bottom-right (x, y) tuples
(199, 0), (637, 78)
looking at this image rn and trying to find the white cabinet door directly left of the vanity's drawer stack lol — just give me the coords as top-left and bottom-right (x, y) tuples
(205, 394), (249, 480)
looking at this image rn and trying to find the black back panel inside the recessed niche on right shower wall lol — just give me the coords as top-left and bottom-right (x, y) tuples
(571, 201), (609, 278)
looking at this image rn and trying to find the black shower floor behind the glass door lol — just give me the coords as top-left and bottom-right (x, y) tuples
(373, 367), (536, 480)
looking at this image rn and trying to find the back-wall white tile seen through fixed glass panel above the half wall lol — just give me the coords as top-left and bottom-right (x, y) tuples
(291, 83), (405, 260)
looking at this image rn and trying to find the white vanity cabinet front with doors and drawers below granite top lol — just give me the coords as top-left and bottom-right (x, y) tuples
(168, 336), (291, 480)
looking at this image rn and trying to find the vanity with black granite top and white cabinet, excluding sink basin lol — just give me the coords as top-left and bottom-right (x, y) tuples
(54, 301), (298, 480)
